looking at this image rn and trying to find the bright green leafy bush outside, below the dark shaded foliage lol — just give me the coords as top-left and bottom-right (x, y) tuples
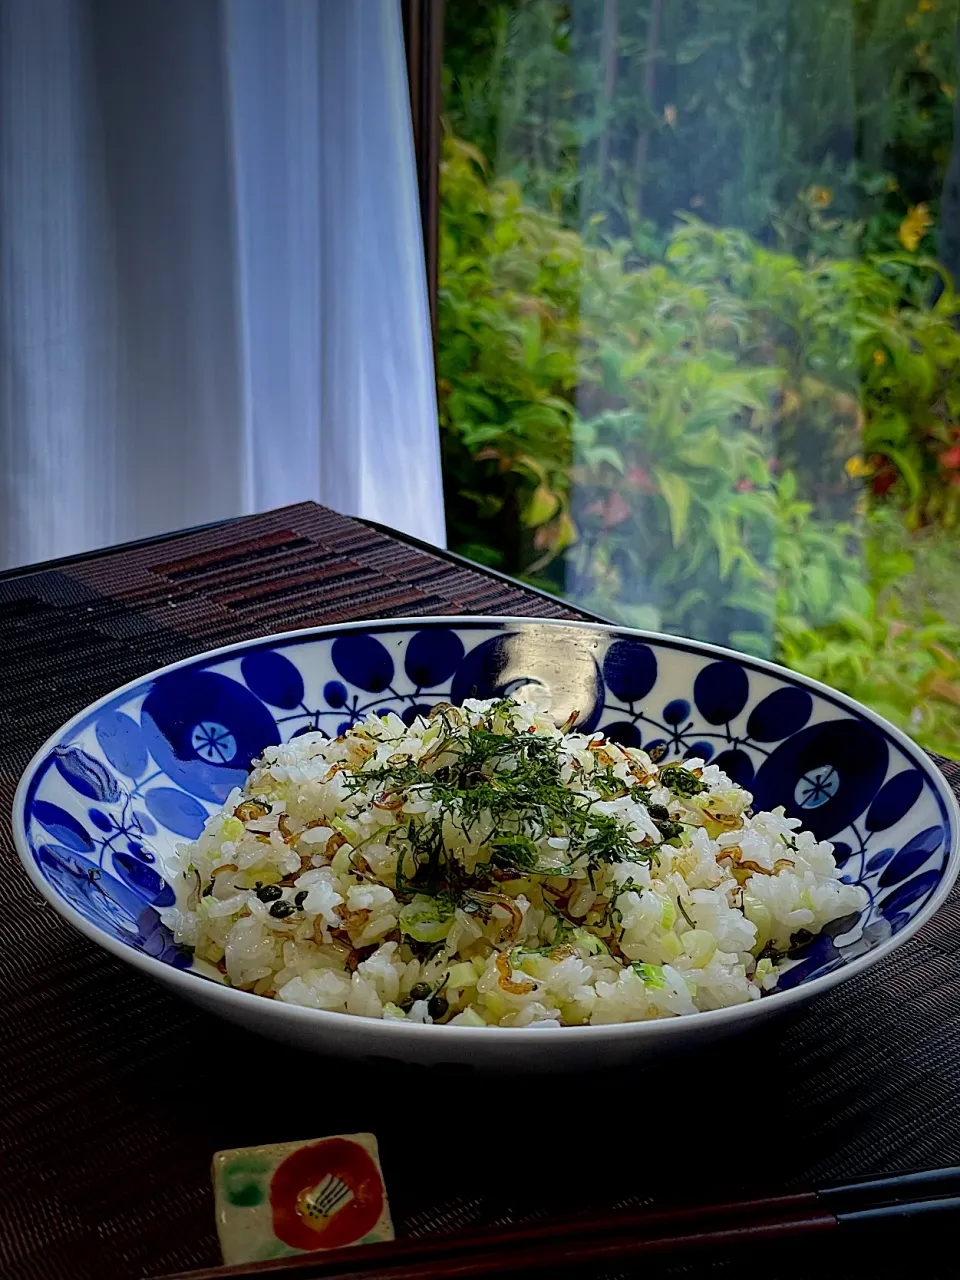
(438, 138), (960, 750)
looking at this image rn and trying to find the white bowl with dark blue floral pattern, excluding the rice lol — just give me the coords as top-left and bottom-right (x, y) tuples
(14, 617), (960, 1069)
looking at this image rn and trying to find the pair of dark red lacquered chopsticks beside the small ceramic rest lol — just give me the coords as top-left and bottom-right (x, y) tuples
(165, 1169), (960, 1280)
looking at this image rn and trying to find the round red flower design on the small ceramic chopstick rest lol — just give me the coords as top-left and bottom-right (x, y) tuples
(270, 1138), (383, 1249)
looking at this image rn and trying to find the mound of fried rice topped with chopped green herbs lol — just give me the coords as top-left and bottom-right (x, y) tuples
(163, 699), (867, 1027)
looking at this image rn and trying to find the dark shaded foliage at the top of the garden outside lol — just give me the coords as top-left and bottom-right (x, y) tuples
(444, 0), (959, 270)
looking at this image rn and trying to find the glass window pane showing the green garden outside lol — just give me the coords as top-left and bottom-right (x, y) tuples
(438, 0), (960, 756)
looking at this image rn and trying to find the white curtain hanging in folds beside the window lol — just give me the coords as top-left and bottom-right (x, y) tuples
(0, 0), (443, 566)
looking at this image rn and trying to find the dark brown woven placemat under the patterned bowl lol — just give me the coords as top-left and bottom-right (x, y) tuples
(0, 504), (960, 1280)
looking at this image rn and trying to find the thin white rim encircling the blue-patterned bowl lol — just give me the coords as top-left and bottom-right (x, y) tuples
(12, 613), (960, 1050)
